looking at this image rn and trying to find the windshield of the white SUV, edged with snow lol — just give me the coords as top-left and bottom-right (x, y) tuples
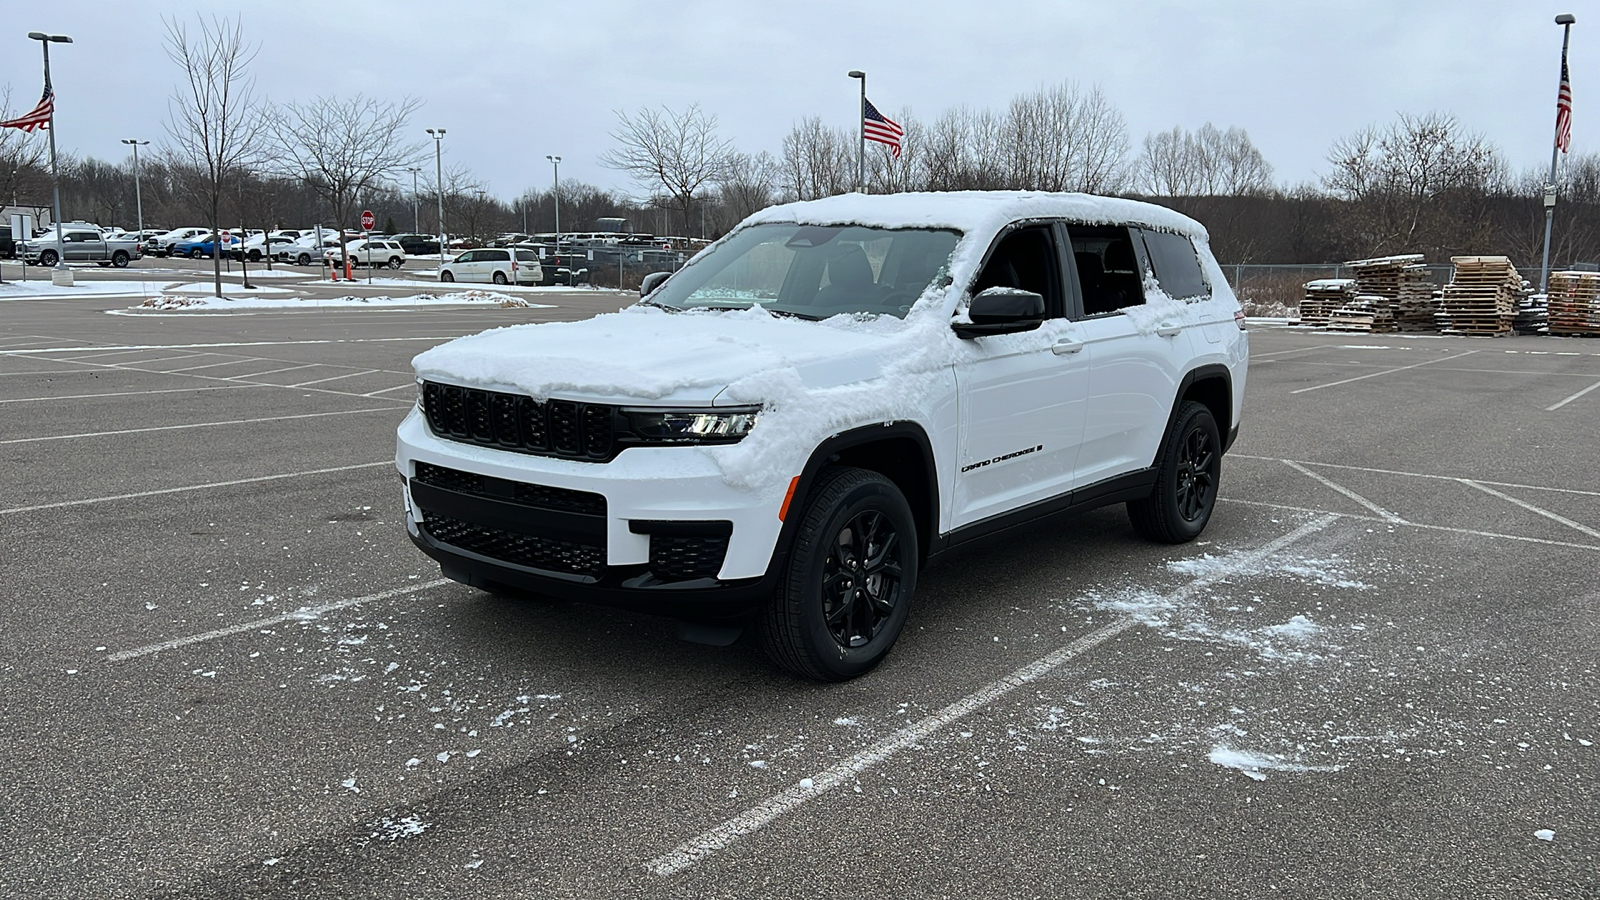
(650, 223), (960, 319)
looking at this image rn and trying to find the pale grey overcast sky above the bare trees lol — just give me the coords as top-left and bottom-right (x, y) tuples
(0, 0), (1600, 199)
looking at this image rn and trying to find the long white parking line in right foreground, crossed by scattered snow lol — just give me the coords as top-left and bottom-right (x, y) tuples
(645, 516), (1338, 876)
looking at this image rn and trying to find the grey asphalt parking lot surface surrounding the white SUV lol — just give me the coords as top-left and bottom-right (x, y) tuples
(0, 267), (1600, 898)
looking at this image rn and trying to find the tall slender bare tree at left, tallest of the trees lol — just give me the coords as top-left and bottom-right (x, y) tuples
(163, 18), (262, 296)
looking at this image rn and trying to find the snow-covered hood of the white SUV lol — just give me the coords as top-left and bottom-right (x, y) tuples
(413, 306), (909, 404)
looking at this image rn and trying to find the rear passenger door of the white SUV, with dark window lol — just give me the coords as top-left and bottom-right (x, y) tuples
(1067, 226), (1198, 488)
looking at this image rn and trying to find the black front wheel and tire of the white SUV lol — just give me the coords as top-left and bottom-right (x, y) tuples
(762, 468), (918, 681)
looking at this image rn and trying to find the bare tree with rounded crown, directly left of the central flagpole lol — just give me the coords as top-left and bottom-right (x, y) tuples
(600, 104), (733, 232)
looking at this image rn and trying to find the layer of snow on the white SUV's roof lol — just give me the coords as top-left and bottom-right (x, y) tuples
(746, 191), (1208, 240)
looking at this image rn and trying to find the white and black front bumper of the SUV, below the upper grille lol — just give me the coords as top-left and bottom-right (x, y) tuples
(395, 408), (782, 615)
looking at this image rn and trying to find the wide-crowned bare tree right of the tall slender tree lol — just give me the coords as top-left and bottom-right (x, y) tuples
(269, 94), (428, 265)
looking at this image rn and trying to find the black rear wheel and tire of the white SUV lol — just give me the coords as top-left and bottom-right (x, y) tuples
(1128, 400), (1222, 544)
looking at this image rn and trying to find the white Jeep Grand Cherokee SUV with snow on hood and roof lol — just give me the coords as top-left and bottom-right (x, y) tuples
(397, 192), (1248, 681)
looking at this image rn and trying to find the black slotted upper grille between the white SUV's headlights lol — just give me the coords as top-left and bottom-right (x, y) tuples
(422, 381), (621, 461)
